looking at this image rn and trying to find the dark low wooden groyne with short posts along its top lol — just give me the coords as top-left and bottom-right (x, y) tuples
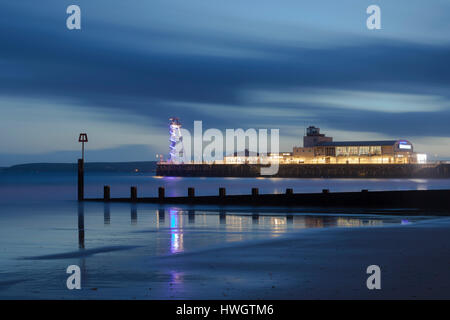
(84, 186), (450, 212)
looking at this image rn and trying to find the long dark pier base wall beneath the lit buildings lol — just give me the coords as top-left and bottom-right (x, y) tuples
(156, 164), (450, 178)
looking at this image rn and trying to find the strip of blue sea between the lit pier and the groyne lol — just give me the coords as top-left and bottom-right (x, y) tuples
(0, 172), (450, 202)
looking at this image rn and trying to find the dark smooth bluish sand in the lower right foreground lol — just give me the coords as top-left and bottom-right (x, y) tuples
(146, 218), (450, 299)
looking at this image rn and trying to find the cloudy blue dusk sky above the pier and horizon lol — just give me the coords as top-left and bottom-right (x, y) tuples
(0, 0), (450, 166)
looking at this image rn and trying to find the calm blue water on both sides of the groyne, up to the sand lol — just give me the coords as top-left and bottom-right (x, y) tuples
(0, 174), (450, 299)
